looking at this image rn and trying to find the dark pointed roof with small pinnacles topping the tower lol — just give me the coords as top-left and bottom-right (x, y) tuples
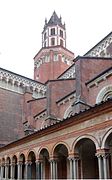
(44, 11), (65, 29)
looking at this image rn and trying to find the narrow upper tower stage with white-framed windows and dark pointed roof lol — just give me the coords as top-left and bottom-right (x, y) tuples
(42, 11), (66, 47)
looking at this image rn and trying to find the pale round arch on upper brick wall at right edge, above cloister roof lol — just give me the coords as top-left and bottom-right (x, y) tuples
(96, 85), (112, 104)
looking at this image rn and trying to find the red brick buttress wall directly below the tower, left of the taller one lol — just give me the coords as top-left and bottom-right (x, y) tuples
(47, 79), (75, 118)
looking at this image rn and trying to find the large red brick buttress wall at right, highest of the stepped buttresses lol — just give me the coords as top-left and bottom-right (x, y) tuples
(76, 58), (112, 103)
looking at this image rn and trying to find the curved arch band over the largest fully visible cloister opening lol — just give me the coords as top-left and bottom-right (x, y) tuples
(72, 134), (100, 152)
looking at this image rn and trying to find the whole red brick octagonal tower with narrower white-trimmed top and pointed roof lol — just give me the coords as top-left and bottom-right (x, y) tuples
(34, 11), (74, 83)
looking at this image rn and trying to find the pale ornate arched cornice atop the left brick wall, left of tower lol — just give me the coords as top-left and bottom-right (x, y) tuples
(0, 68), (46, 97)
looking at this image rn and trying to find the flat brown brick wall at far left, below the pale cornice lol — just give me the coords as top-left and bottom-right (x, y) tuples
(0, 88), (24, 144)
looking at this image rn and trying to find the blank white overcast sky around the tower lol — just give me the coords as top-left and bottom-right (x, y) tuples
(0, 0), (112, 78)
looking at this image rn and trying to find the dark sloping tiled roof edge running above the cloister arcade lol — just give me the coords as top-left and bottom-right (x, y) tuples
(0, 98), (112, 152)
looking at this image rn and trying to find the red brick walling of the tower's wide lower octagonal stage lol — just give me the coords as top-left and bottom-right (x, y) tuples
(34, 47), (74, 83)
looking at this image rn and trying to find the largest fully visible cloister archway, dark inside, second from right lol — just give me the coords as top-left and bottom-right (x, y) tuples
(73, 134), (99, 179)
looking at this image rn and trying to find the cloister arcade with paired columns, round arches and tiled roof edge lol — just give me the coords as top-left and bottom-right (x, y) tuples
(0, 100), (112, 179)
